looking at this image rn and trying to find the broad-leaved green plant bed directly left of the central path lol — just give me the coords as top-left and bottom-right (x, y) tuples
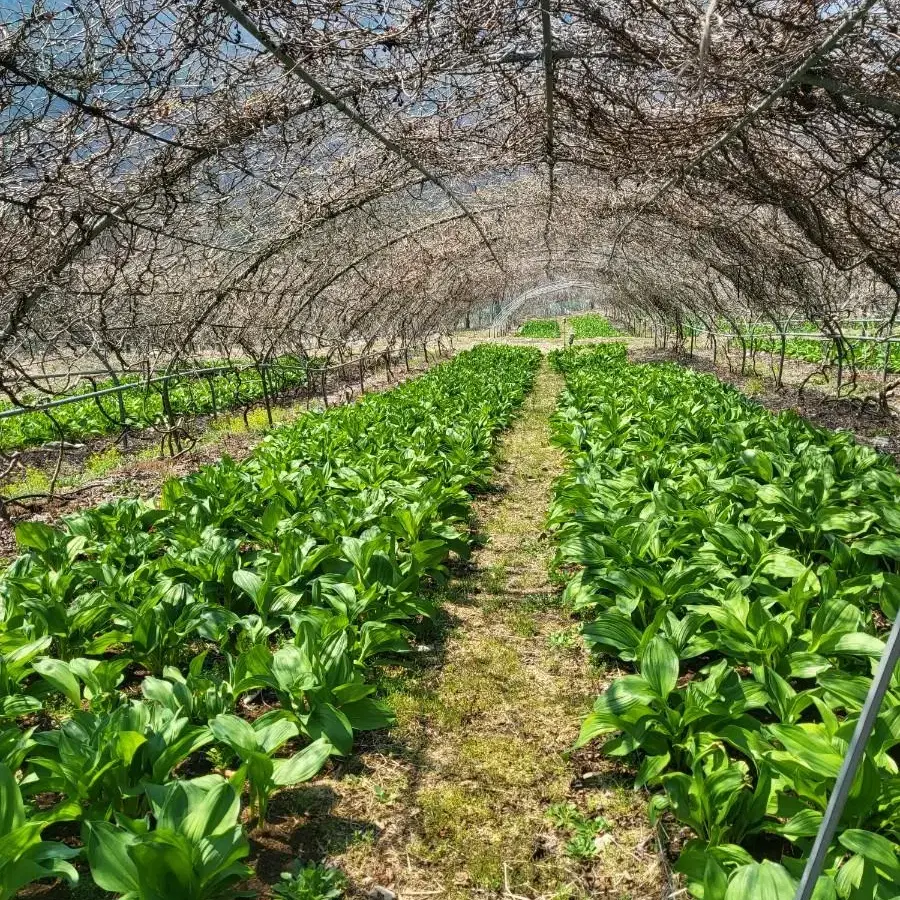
(0, 346), (540, 900)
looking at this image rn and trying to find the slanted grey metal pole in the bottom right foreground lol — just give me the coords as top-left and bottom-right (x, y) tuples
(794, 616), (900, 900)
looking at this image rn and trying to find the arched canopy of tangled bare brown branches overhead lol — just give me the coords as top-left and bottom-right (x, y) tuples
(0, 0), (900, 384)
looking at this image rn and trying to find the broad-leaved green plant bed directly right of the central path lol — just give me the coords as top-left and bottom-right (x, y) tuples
(550, 346), (900, 900)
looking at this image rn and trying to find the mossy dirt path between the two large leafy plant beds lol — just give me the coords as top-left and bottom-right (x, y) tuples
(266, 364), (662, 900)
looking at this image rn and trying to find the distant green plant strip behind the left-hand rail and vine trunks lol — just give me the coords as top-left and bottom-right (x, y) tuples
(0, 356), (308, 451)
